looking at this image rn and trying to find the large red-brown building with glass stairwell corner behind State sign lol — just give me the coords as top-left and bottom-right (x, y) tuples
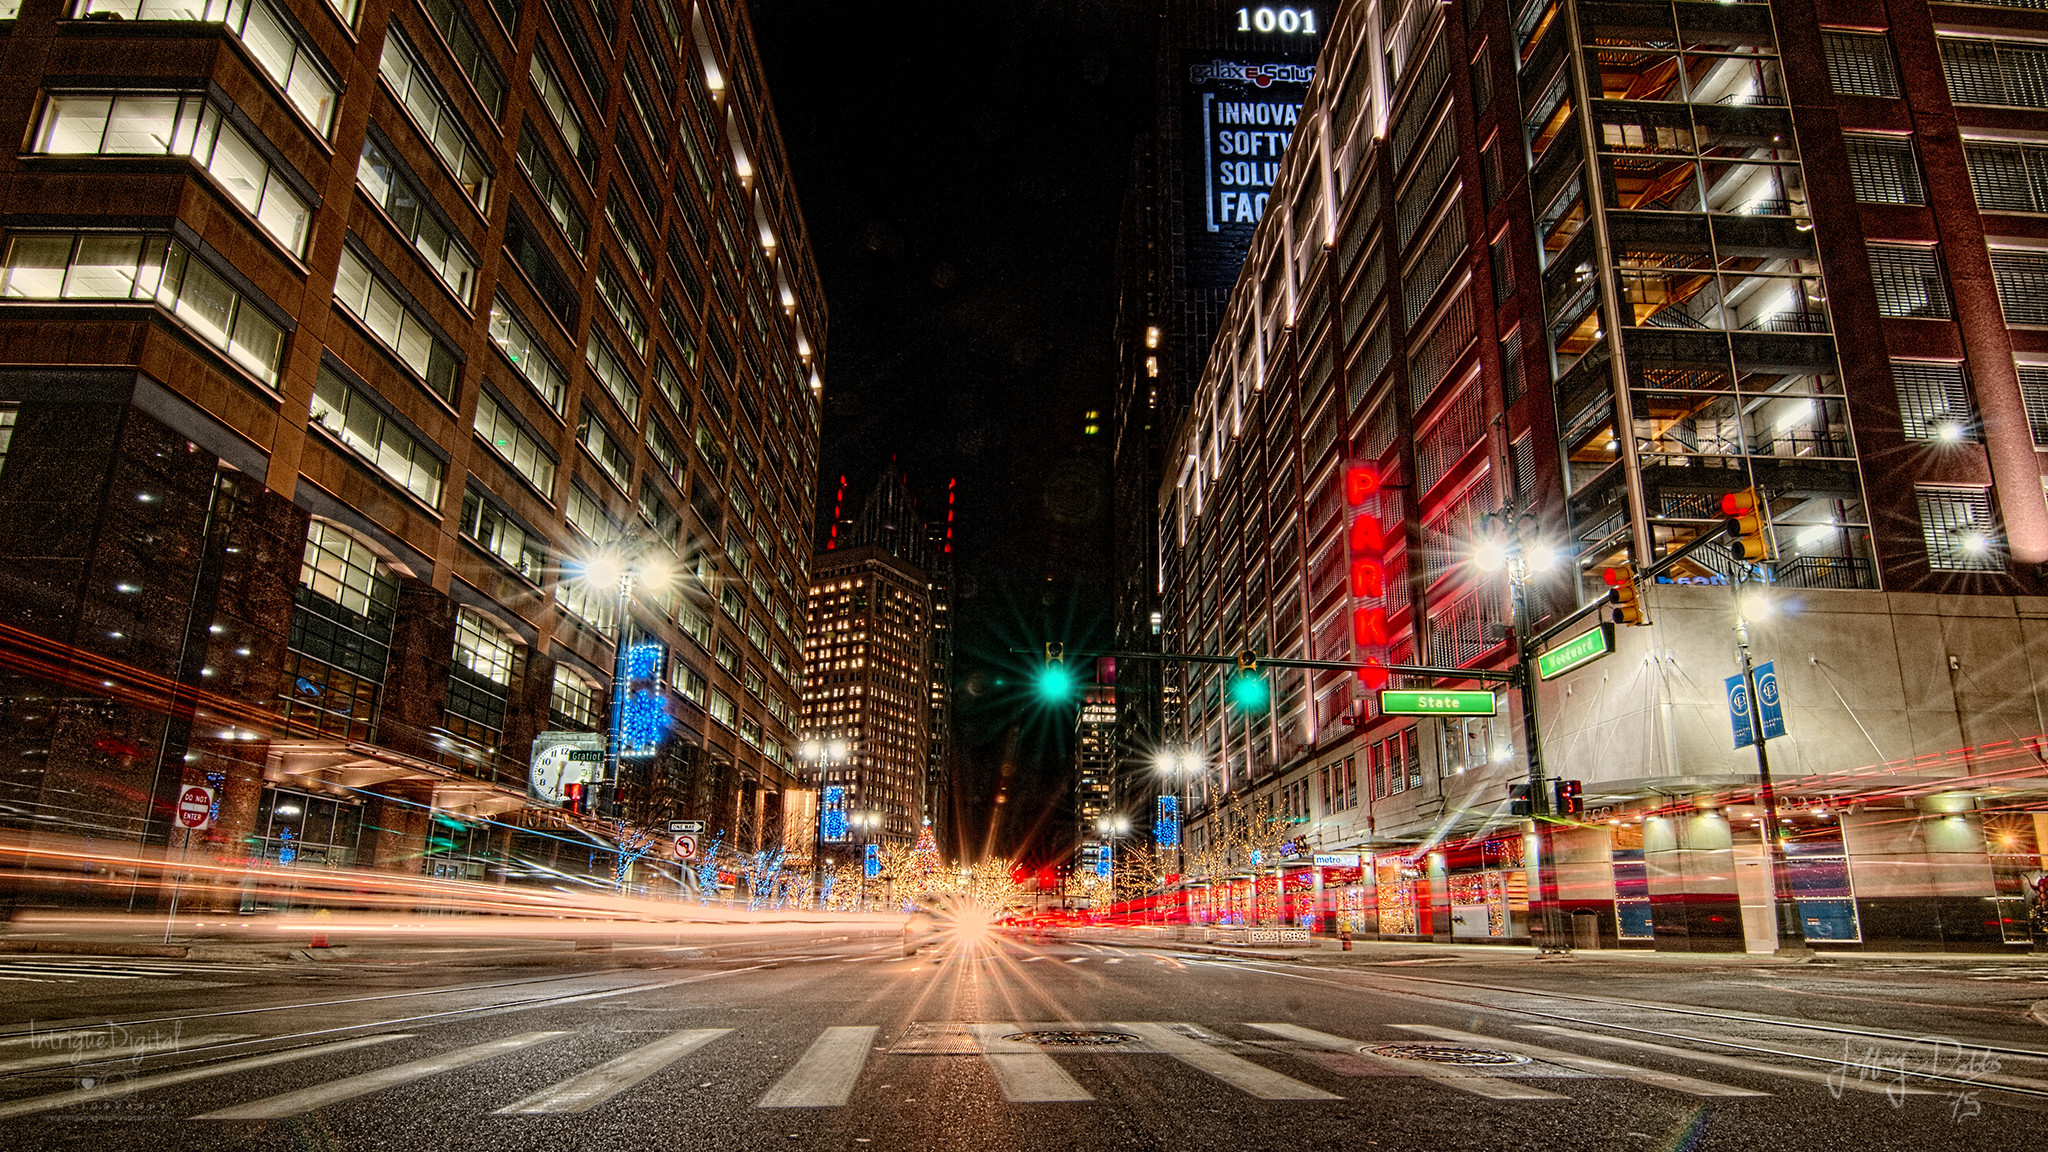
(1159, 0), (2048, 949)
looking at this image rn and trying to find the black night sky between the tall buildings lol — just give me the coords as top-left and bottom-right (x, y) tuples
(754, 0), (1157, 859)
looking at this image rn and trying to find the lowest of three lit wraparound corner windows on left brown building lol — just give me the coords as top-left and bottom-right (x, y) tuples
(0, 232), (285, 383)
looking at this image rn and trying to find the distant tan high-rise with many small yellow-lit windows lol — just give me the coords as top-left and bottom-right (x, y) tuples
(801, 537), (932, 853)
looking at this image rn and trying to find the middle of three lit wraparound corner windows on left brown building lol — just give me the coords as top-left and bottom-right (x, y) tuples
(31, 92), (313, 256)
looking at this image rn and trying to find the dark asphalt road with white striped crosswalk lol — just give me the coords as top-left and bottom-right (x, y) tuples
(0, 937), (2048, 1152)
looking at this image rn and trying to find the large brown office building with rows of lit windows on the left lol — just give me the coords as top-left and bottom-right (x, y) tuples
(0, 0), (825, 875)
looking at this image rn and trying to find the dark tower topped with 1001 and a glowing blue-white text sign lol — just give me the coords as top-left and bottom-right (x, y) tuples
(1110, 0), (1327, 844)
